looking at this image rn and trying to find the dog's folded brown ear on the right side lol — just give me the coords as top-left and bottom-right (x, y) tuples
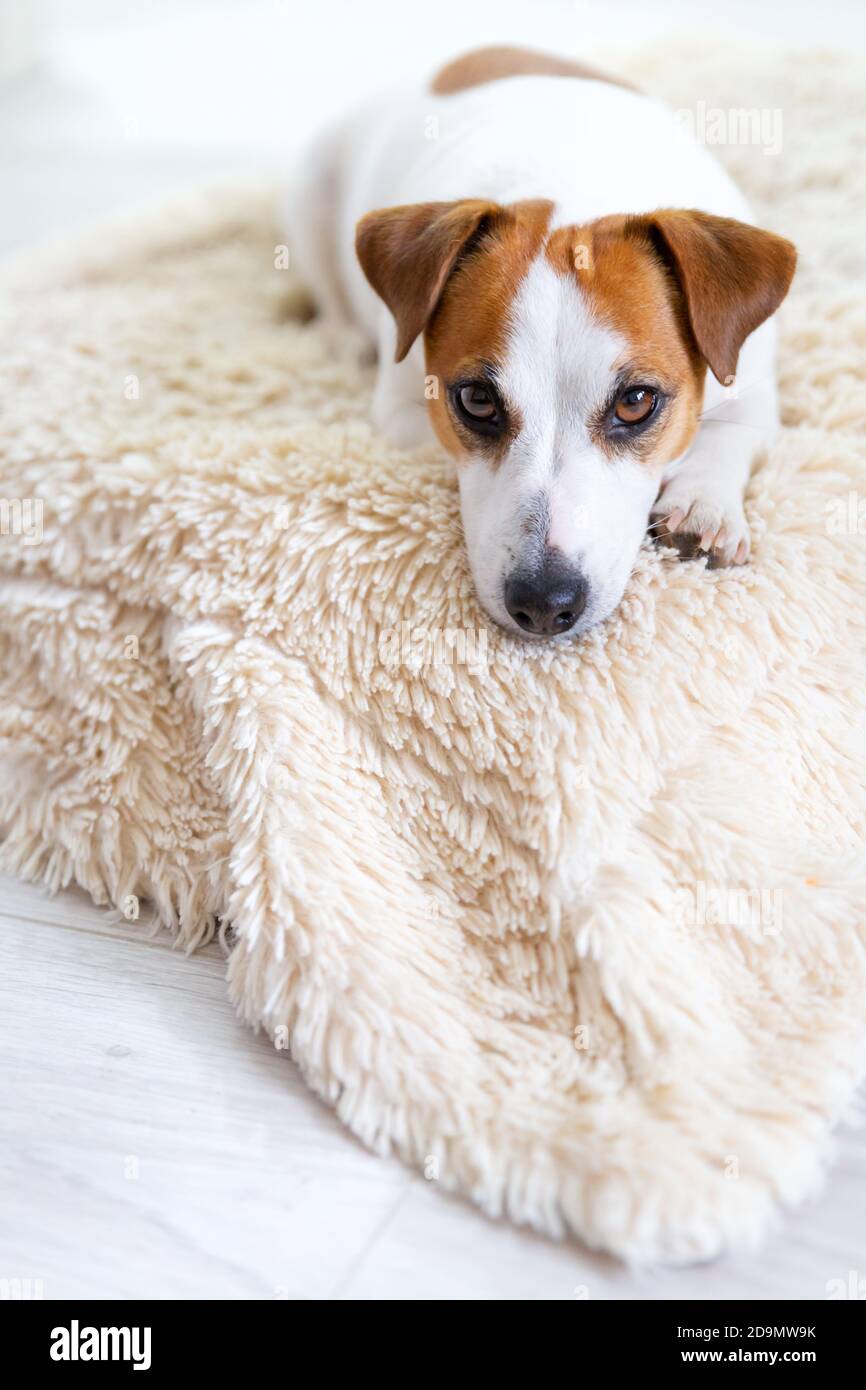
(627, 209), (796, 385)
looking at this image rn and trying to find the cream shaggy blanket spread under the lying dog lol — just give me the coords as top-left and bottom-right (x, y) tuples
(0, 47), (866, 1259)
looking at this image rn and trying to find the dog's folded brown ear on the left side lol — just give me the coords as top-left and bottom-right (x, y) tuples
(354, 199), (502, 361)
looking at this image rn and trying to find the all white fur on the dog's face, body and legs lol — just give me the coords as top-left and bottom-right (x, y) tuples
(289, 66), (777, 631)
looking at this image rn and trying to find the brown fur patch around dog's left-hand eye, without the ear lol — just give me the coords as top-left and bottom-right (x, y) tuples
(424, 199), (553, 457)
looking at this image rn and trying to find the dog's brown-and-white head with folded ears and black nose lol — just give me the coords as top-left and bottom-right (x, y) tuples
(356, 199), (795, 637)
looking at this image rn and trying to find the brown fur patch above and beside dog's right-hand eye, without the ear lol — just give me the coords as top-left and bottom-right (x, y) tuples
(545, 215), (706, 468)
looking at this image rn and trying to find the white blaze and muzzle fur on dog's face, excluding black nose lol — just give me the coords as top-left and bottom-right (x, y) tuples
(459, 257), (656, 631)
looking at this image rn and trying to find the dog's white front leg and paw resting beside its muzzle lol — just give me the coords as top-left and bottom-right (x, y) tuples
(651, 329), (778, 567)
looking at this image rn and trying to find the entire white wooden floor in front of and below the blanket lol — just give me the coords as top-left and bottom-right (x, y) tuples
(0, 880), (866, 1300)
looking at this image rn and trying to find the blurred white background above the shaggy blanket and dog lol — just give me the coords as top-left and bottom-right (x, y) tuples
(0, 0), (866, 250)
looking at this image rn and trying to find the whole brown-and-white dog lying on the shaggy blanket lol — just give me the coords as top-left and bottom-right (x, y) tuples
(288, 49), (796, 639)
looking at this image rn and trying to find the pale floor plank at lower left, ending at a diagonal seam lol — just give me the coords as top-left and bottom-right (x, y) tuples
(0, 895), (410, 1298)
